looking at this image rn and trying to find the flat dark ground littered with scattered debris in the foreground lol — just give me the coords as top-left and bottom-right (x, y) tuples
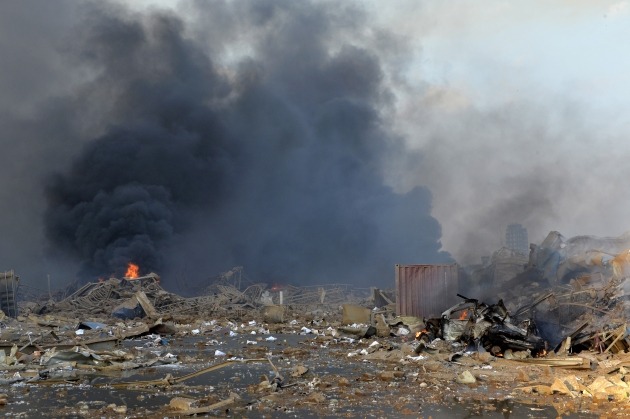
(0, 313), (630, 418)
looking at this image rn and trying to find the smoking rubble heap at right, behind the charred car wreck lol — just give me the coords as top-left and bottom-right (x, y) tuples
(456, 232), (630, 360)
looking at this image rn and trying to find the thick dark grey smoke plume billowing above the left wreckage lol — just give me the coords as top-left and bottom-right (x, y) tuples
(35, 1), (450, 285)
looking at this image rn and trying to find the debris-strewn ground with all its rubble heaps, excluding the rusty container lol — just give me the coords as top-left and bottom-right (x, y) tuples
(0, 233), (630, 417)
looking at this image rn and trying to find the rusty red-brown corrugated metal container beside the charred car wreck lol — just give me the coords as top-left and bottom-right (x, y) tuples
(395, 264), (459, 318)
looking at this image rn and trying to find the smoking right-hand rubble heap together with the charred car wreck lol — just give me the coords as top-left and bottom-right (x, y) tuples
(412, 231), (630, 356)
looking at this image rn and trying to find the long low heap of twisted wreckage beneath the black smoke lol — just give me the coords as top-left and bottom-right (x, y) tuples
(19, 268), (367, 319)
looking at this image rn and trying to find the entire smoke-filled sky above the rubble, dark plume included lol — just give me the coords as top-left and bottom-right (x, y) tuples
(0, 0), (630, 284)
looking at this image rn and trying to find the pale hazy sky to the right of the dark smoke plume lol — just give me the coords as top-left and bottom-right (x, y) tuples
(383, 1), (630, 260)
